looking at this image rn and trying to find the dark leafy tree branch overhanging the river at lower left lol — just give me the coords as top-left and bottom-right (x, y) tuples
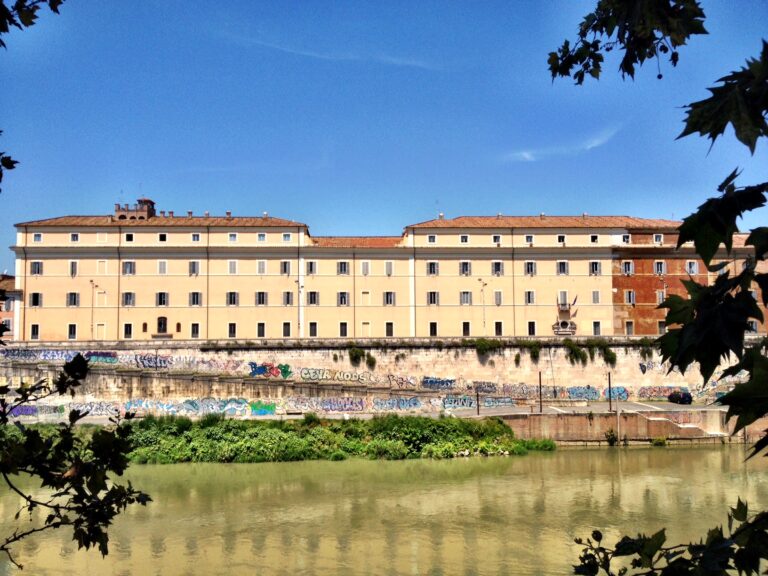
(0, 354), (150, 567)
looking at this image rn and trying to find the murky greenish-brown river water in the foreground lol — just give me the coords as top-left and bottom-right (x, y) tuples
(0, 446), (768, 576)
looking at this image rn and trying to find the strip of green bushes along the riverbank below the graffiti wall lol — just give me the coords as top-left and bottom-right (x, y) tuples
(130, 414), (555, 464)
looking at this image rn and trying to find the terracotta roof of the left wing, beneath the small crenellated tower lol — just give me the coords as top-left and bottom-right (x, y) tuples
(16, 216), (307, 228)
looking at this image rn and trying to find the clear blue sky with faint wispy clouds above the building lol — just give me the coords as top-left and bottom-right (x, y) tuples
(0, 0), (768, 269)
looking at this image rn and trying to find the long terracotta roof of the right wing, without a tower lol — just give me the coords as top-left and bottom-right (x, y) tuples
(407, 215), (680, 229)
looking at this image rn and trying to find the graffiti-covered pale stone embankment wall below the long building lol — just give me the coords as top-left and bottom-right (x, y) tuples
(0, 342), (738, 417)
